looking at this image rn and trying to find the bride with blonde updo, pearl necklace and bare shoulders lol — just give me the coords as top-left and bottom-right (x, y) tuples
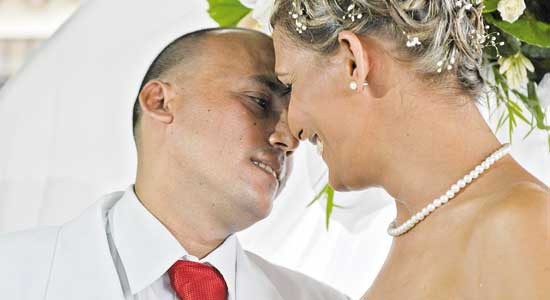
(271, 0), (550, 300)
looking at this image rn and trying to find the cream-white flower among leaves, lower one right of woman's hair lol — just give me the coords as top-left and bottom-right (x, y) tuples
(498, 52), (535, 90)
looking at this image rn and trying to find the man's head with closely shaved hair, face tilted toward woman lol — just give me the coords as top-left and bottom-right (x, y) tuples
(134, 25), (298, 238)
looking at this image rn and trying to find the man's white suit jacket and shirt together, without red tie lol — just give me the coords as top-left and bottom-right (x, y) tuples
(0, 188), (349, 300)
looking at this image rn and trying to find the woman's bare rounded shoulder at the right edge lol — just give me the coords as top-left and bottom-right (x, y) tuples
(468, 182), (550, 299)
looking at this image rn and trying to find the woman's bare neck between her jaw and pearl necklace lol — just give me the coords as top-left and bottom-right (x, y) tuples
(381, 98), (500, 224)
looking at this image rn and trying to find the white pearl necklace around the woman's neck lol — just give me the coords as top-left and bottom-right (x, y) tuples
(388, 144), (510, 237)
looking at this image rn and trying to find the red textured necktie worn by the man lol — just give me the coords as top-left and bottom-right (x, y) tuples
(168, 260), (227, 300)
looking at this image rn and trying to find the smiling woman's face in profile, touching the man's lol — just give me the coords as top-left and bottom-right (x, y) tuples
(273, 28), (386, 191)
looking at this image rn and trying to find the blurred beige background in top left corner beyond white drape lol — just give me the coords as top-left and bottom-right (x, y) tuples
(0, 0), (80, 88)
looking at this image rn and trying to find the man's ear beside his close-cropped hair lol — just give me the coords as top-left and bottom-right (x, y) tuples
(139, 80), (174, 124)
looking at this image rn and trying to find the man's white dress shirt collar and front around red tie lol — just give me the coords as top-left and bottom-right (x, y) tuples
(107, 186), (237, 300)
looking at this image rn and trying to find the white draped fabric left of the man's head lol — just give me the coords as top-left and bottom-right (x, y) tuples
(0, 0), (215, 230)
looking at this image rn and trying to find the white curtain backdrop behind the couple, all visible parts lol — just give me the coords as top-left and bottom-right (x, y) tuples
(0, 0), (550, 298)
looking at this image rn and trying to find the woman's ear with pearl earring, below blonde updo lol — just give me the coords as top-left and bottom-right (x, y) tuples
(338, 30), (370, 91)
